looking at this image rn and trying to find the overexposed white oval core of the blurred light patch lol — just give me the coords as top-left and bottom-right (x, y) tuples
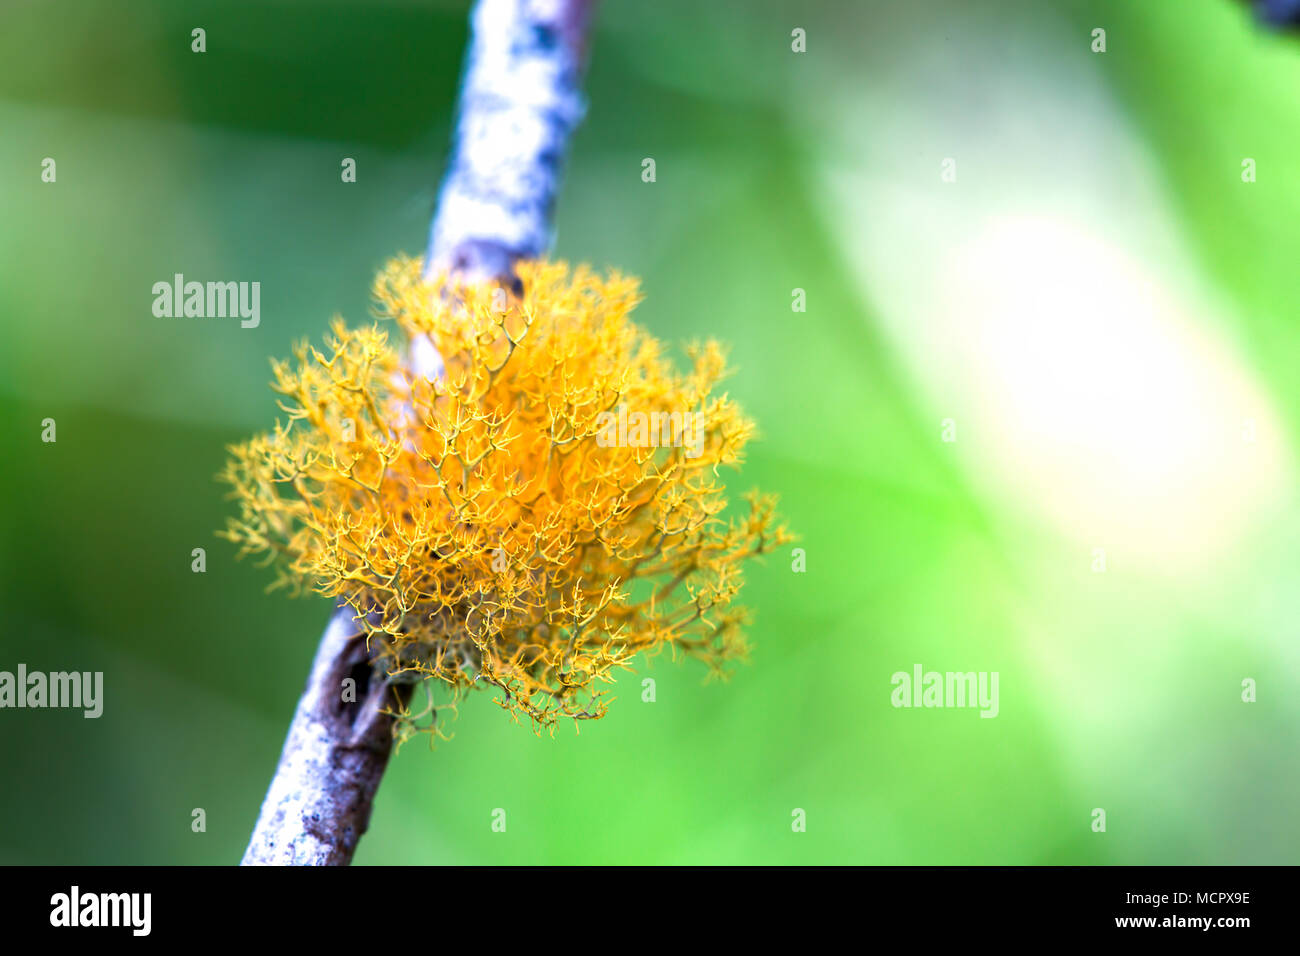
(931, 217), (1287, 564)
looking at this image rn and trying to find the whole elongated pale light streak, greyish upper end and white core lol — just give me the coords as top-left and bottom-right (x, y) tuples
(819, 22), (1295, 574)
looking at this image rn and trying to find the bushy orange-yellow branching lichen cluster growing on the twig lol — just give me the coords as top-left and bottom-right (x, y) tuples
(222, 259), (789, 730)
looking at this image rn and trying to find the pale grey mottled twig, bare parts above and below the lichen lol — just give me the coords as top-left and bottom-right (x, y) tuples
(242, 0), (592, 866)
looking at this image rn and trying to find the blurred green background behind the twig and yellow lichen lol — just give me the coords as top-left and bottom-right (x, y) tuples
(0, 0), (1300, 864)
